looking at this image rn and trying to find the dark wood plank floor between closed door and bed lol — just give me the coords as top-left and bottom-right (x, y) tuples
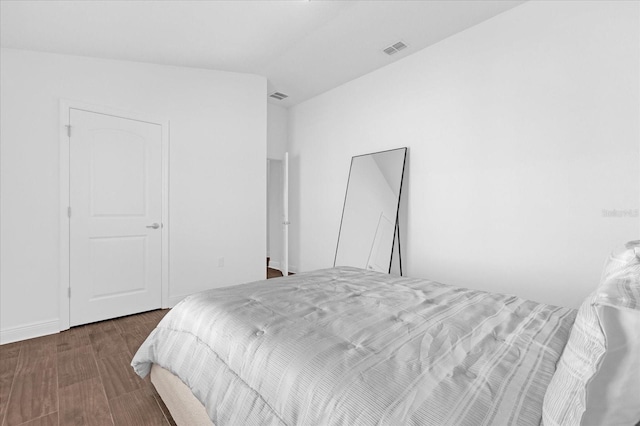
(0, 309), (175, 426)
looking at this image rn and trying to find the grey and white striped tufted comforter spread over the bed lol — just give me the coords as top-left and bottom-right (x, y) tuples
(132, 267), (576, 426)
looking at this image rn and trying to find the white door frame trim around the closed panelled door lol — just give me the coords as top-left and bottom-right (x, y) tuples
(58, 99), (170, 331)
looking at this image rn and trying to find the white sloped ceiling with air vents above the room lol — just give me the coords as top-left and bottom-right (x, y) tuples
(0, 0), (523, 107)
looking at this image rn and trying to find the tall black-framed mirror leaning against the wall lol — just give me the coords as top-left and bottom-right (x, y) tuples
(333, 148), (407, 273)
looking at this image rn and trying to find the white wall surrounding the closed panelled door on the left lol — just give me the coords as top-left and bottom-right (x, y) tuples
(0, 49), (267, 342)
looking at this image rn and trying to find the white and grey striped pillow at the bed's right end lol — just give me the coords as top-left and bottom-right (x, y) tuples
(542, 241), (640, 426)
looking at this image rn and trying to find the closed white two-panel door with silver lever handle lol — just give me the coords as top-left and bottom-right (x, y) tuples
(69, 109), (162, 326)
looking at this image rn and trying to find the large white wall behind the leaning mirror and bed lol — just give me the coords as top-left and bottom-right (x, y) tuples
(289, 1), (640, 307)
